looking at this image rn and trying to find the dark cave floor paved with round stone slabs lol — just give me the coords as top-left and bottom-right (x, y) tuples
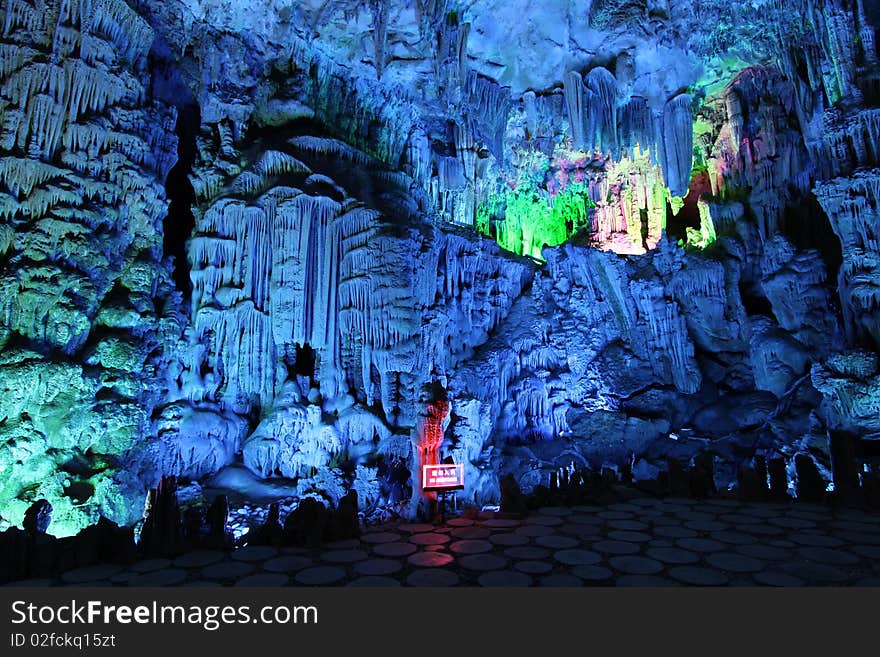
(6, 497), (880, 586)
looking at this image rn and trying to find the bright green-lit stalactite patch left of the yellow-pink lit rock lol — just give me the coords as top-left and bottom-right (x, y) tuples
(477, 182), (595, 260)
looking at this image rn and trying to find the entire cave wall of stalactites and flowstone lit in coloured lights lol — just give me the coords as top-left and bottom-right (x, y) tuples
(0, 0), (880, 530)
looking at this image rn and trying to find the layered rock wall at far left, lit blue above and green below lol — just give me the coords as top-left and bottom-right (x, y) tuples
(0, 0), (179, 534)
